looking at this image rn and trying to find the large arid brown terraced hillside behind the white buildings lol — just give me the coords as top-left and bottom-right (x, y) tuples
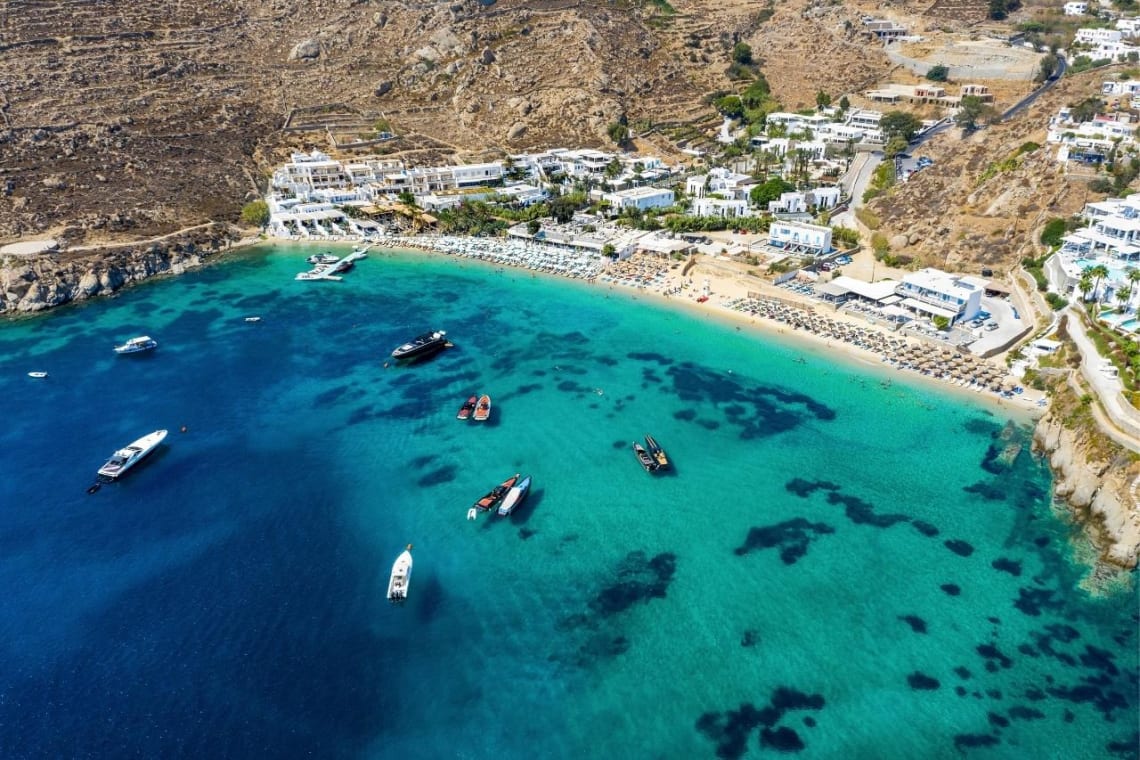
(0, 0), (912, 244)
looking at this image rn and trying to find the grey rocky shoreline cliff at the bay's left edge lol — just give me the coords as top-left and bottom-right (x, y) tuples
(0, 224), (238, 313)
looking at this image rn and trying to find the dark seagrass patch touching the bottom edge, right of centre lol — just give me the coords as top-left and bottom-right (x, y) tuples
(695, 686), (824, 760)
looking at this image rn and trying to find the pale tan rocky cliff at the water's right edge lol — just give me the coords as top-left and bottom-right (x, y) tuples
(1034, 384), (1140, 567)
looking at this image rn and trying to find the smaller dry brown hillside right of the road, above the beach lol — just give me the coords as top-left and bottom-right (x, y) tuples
(870, 67), (1114, 271)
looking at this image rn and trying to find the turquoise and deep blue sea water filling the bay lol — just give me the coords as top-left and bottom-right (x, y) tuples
(0, 247), (1138, 759)
